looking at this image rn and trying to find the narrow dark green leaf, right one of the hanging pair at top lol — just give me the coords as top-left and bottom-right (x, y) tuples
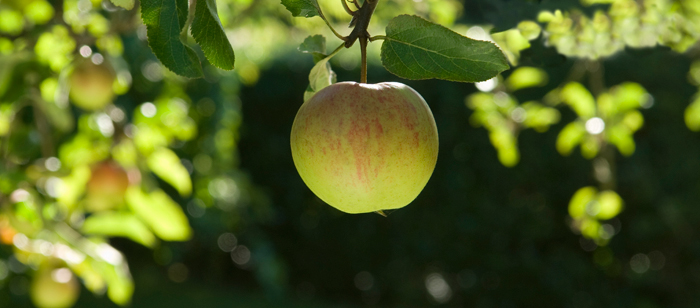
(192, 0), (235, 70)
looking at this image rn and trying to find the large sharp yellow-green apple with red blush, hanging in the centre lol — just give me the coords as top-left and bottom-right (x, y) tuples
(291, 82), (438, 214)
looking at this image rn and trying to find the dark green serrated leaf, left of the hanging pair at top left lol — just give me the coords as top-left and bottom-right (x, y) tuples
(141, 0), (202, 78)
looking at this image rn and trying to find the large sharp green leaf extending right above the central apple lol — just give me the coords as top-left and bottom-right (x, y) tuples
(381, 15), (509, 82)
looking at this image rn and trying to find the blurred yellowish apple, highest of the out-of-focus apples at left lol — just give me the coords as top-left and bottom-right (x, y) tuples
(69, 60), (114, 111)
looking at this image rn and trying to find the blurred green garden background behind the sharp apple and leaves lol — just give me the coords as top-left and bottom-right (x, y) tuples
(0, 0), (700, 307)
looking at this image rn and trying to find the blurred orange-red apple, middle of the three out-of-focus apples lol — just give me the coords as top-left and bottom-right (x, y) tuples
(85, 161), (129, 212)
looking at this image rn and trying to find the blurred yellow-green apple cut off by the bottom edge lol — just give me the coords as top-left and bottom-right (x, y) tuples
(29, 265), (80, 308)
